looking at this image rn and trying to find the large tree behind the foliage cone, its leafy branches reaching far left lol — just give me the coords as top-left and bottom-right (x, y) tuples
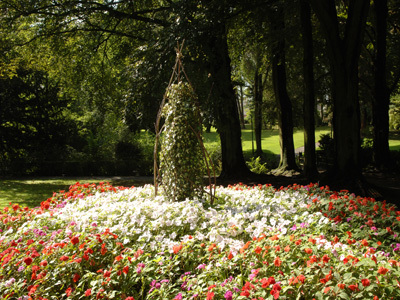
(1, 0), (253, 176)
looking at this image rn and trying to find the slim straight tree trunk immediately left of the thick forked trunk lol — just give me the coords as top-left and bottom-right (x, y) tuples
(300, 0), (318, 179)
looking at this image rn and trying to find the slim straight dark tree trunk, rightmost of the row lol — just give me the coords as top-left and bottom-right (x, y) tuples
(372, 0), (390, 168)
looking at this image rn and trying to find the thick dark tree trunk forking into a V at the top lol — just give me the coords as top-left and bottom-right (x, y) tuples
(309, 0), (369, 186)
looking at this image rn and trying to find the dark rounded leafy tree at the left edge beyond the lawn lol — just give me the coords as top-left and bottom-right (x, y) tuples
(0, 67), (74, 175)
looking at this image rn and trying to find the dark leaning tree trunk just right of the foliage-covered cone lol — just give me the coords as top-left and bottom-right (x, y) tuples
(206, 23), (250, 178)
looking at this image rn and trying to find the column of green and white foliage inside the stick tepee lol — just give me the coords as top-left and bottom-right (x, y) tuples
(160, 82), (205, 201)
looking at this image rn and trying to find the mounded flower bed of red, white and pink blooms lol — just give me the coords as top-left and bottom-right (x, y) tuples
(0, 183), (400, 300)
